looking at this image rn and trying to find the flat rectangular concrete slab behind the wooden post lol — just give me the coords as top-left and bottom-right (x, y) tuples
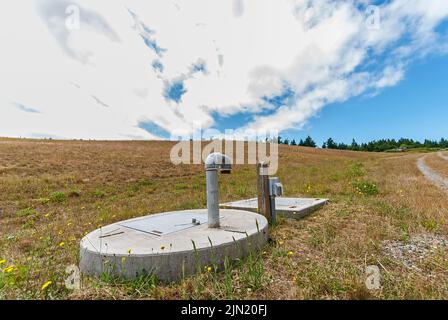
(220, 197), (328, 219)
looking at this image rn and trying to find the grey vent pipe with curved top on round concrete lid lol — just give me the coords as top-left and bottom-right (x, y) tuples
(205, 152), (232, 228)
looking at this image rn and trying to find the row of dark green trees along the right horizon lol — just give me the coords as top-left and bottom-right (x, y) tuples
(278, 136), (448, 152)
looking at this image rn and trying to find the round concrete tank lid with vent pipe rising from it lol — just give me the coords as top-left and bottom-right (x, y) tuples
(80, 209), (268, 281)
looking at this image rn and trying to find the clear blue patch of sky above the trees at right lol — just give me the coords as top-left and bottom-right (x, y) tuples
(282, 56), (448, 145)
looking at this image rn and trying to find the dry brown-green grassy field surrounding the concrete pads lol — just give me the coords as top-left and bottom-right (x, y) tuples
(0, 139), (448, 299)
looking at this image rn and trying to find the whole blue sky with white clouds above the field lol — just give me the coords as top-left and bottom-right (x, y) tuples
(0, 0), (448, 144)
